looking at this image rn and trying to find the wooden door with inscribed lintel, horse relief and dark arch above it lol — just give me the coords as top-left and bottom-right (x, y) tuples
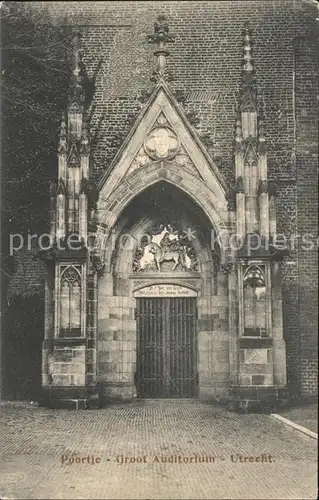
(120, 181), (205, 398)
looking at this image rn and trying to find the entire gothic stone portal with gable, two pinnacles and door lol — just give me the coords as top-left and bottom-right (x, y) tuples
(42, 18), (287, 409)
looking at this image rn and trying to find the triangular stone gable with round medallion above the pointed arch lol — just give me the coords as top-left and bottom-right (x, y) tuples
(99, 81), (226, 204)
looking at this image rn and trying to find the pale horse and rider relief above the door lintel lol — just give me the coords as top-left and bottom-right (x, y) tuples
(133, 224), (198, 271)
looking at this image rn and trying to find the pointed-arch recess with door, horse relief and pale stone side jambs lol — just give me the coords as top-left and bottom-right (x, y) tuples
(98, 181), (229, 399)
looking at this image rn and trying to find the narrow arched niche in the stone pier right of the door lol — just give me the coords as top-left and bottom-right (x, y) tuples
(243, 264), (268, 337)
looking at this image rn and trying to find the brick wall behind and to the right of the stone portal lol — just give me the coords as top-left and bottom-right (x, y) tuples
(10, 0), (318, 393)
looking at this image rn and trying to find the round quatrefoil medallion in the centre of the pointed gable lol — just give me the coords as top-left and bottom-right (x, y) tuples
(144, 127), (179, 160)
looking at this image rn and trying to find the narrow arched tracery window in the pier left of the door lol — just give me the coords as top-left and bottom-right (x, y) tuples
(60, 266), (81, 337)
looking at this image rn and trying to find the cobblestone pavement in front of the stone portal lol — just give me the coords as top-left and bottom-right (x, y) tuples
(0, 400), (317, 500)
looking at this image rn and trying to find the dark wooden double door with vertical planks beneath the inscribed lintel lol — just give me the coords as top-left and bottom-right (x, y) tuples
(136, 297), (197, 398)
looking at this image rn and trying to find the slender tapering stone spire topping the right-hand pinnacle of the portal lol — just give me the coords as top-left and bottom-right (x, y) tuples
(240, 23), (256, 112)
